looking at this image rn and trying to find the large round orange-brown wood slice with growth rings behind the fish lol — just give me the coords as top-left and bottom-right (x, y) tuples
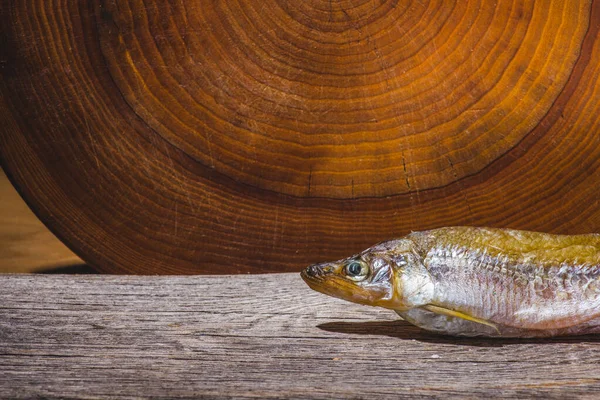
(0, 0), (600, 274)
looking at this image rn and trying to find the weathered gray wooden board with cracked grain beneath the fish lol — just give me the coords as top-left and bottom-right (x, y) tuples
(0, 274), (600, 399)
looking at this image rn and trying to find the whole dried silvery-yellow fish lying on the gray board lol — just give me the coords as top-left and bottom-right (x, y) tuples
(302, 227), (600, 337)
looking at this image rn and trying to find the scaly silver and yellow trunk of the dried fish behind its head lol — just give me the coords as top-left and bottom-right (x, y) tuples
(410, 228), (600, 337)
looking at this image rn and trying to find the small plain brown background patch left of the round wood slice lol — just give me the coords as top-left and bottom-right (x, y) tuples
(0, 169), (83, 273)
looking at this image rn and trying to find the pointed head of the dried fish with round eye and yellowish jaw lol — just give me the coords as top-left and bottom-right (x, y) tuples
(300, 239), (422, 310)
